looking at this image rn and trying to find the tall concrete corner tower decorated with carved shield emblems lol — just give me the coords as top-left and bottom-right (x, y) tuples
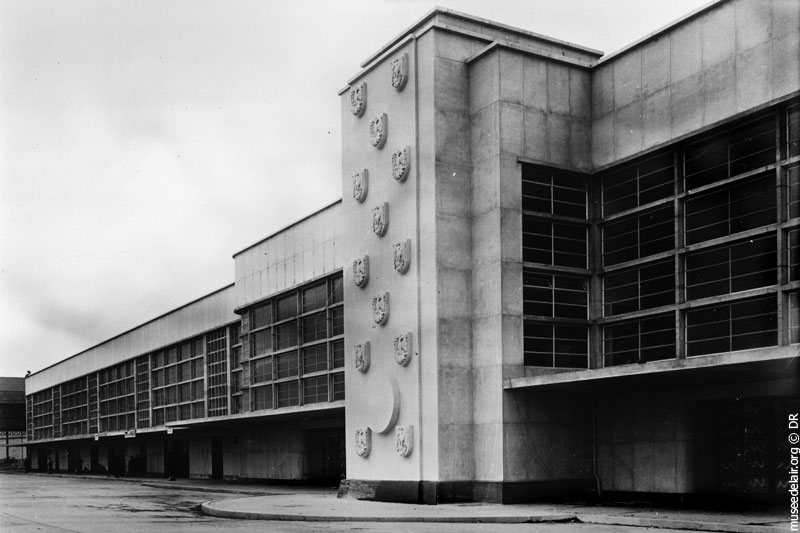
(340, 9), (600, 503)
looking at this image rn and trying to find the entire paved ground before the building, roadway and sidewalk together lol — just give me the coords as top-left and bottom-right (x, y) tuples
(0, 474), (788, 533)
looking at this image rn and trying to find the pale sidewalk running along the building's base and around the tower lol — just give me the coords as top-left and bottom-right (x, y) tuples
(18, 474), (789, 533)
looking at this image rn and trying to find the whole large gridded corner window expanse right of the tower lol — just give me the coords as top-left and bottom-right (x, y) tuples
(522, 101), (800, 368)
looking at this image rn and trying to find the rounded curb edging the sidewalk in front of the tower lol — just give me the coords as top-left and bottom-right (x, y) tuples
(200, 501), (781, 533)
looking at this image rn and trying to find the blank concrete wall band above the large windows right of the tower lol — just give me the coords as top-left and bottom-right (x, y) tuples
(591, 0), (800, 168)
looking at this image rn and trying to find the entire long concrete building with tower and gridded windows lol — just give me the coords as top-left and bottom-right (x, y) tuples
(26, 0), (800, 503)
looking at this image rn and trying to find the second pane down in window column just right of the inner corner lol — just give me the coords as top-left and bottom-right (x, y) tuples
(603, 205), (675, 265)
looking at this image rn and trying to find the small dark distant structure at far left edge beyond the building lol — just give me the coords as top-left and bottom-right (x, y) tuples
(0, 377), (25, 467)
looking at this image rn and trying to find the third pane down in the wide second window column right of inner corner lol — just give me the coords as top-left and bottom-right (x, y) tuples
(686, 235), (777, 300)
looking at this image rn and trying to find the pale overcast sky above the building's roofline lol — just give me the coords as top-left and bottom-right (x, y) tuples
(0, 0), (707, 376)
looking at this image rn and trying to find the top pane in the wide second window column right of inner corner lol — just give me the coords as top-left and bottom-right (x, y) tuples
(684, 115), (775, 190)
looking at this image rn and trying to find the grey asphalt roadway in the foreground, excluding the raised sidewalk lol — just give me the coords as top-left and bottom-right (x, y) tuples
(0, 474), (700, 533)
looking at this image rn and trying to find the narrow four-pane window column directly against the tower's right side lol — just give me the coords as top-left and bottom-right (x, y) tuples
(522, 164), (590, 368)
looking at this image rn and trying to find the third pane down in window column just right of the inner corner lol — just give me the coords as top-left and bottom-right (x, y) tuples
(603, 258), (675, 316)
